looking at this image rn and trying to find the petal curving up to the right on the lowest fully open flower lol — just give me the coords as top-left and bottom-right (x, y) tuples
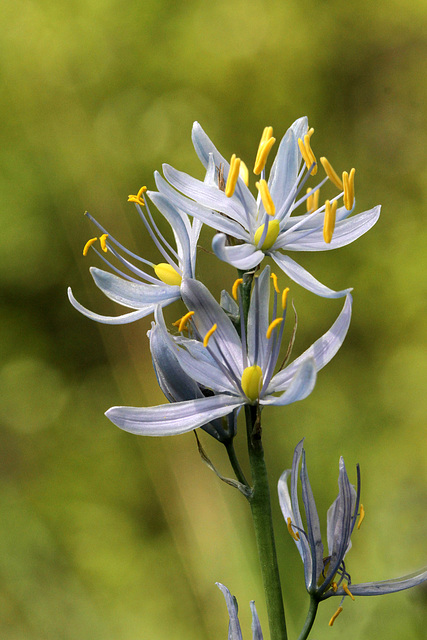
(267, 294), (353, 393)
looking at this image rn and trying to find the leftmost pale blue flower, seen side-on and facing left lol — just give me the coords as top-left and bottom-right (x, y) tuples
(68, 187), (201, 324)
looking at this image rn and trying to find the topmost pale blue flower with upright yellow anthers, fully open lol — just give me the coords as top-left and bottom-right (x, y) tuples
(156, 117), (380, 298)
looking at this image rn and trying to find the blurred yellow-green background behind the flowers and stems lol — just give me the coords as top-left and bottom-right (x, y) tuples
(0, 0), (427, 640)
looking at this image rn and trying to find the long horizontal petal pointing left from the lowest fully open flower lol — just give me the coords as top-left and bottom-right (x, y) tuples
(105, 394), (243, 436)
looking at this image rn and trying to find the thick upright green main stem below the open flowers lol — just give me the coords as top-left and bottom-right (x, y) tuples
(245, 405), (288, 640)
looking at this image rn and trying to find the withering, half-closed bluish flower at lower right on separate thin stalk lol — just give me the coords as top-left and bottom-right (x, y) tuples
(278, 440), (427, 626)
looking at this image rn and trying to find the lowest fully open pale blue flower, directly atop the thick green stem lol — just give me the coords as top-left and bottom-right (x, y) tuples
(106, 267), (352, 436)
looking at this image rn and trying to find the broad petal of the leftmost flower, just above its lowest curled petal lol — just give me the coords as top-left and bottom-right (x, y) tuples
(90, 267), (180, 309)
